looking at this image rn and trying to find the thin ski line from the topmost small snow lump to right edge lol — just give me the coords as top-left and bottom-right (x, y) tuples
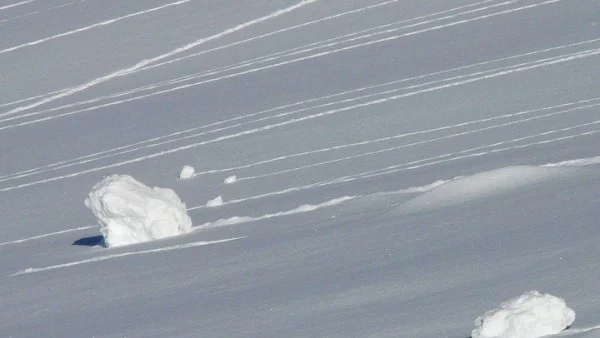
(193, 97), (600, 180)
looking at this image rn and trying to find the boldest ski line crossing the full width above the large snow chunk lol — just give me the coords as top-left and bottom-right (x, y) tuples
(0, 49), (600, 192)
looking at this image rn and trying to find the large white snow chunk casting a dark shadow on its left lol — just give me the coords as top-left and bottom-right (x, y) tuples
(85, 175), (192, 247)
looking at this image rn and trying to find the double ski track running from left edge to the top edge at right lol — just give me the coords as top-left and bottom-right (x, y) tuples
(0, 0), (563, 125)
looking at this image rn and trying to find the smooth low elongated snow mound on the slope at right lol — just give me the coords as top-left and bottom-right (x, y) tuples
(398, 166), (571, 213)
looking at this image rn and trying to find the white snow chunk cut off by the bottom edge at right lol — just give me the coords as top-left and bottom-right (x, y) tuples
(471, 290), (575, 338)
